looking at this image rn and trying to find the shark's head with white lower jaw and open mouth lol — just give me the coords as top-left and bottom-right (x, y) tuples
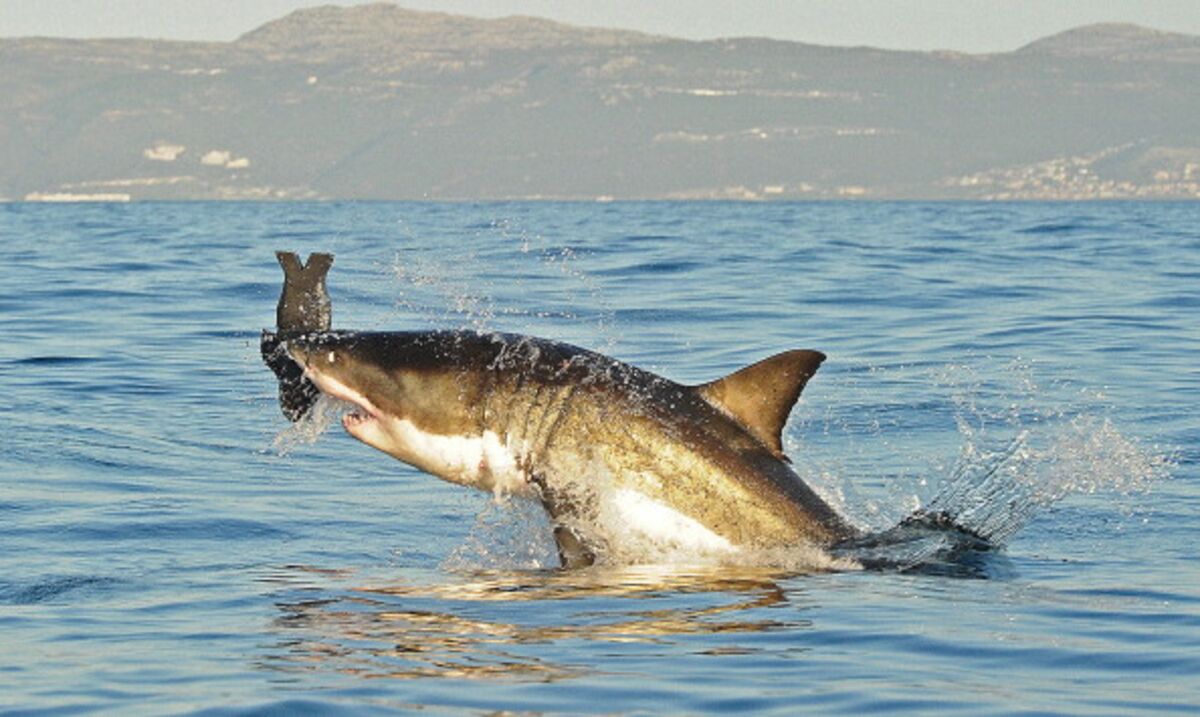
(287, 332), (482, 481)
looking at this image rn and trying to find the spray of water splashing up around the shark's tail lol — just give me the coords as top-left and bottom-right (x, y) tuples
(790, 357), (1174, 573)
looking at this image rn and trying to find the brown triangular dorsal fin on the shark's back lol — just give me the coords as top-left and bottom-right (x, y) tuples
(696, 349), (824, 460)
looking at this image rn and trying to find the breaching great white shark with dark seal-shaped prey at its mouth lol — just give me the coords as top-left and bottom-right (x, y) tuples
(263, 253), (988, 567)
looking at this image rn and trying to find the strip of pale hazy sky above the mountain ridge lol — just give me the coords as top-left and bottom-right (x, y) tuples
(0, 0), (1200, 52)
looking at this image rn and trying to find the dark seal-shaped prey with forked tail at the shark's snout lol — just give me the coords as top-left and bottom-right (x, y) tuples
(259, 252), (334, 422)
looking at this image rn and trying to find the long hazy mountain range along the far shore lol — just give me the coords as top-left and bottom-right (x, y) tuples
(0, 4), (1200, 199)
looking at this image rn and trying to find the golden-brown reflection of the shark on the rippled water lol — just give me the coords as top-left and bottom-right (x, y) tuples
(260, 566), (811, 682)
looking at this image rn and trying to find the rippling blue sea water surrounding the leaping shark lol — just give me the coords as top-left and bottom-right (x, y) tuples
(0, 203), (1200, 715)
